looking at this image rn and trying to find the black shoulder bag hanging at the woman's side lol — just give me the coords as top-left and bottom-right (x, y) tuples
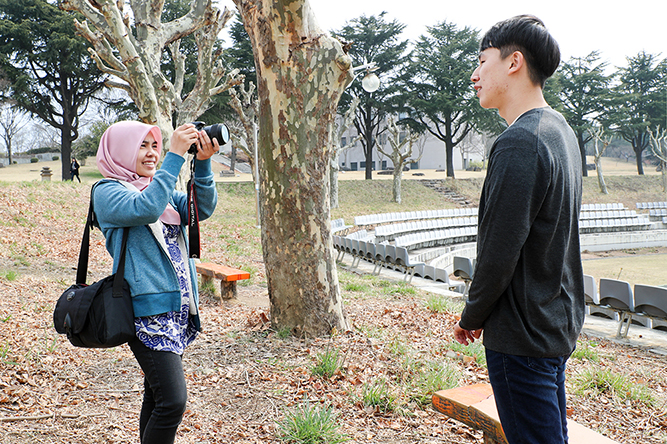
(53, 186), (136, 348)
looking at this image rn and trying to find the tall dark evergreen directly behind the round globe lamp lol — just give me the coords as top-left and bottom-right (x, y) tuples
(332, 12), (408, 180)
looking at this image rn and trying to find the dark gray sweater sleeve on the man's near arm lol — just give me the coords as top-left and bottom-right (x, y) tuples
(459, 134), (549, 330)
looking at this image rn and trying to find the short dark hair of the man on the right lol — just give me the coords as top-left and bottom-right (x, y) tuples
(479, 15), (560, 88)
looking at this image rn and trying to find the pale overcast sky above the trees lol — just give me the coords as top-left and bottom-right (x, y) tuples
(219, 0), (667, 70)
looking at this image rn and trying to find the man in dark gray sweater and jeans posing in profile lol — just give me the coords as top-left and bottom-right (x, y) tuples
(454, 16), (584, 444)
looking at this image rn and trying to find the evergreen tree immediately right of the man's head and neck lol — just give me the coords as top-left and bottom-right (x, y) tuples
(554, 51), (611, 176)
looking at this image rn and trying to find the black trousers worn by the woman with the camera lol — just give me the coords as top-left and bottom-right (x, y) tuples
(129, 339), (188, 444)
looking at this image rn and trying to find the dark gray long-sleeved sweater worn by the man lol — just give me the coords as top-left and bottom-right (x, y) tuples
(460, 108), (584, 357)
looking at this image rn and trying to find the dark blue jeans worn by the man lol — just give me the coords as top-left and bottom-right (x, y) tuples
(486, 349), (569, 444)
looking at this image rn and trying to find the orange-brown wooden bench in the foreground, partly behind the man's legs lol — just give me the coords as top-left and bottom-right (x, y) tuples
(432, 384), (618, 444)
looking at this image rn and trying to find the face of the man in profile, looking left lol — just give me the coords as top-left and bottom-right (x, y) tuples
(470, 48), (511, 109)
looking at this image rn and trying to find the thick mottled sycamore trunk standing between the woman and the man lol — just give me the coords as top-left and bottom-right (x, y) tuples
(234, 0), (352, 336)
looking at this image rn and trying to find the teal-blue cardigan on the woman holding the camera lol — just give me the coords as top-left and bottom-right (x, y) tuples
(93, 152), (218, 329)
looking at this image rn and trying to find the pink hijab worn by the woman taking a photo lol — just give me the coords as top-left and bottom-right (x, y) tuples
(97, 121), (181, 225)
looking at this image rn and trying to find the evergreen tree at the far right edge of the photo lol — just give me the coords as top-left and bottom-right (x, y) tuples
(605, 52), (667, 174)
